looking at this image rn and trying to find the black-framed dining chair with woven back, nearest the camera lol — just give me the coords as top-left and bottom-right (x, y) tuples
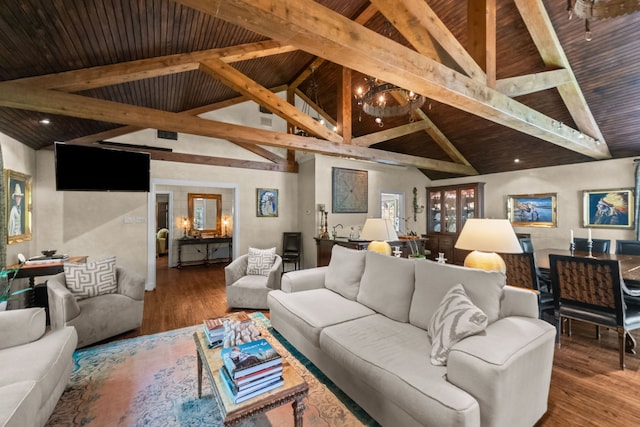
(549, 255), (640, 369)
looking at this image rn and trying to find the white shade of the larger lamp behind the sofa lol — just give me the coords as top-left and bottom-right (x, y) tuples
(455, 218), (522, 253)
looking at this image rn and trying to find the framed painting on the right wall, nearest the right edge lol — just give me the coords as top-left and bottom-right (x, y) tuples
(582, 188), (635, 228)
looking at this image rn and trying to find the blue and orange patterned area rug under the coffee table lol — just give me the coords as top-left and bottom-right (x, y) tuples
(47, 313), (377, 427)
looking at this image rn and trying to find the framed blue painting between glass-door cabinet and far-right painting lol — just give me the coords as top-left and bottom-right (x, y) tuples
(507, 193), (557, 227)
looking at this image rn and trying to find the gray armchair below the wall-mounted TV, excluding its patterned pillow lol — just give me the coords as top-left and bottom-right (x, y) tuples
(47, 267), (144, 348)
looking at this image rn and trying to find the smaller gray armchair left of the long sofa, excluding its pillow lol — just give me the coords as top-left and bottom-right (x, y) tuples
(224, 254), (282, 310)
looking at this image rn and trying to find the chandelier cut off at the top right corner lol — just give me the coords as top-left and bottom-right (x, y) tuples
(567, 0), (640, 41)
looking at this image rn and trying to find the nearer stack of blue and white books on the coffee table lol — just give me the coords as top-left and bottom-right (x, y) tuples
(219, 339), (284, 404)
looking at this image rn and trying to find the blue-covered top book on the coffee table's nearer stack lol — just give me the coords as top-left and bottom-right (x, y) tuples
(220, 338), (282, 379)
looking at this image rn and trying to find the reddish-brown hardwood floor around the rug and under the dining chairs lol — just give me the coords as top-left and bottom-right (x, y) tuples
(115, 257), (640, 427)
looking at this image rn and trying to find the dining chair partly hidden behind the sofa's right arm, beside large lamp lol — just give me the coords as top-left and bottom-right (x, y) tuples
(500, 252), (555, 319)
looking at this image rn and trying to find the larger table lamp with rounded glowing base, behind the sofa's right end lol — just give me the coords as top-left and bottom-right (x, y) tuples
(455, 218), (522, 273)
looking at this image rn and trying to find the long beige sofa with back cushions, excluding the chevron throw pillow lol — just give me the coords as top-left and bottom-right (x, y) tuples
(268, 245), (555, 427)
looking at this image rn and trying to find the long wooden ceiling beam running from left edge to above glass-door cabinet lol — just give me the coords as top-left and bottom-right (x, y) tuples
(0, 82), (475, 175)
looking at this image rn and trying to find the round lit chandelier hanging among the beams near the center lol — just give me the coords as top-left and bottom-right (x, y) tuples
(354, 77), (425, 127)
